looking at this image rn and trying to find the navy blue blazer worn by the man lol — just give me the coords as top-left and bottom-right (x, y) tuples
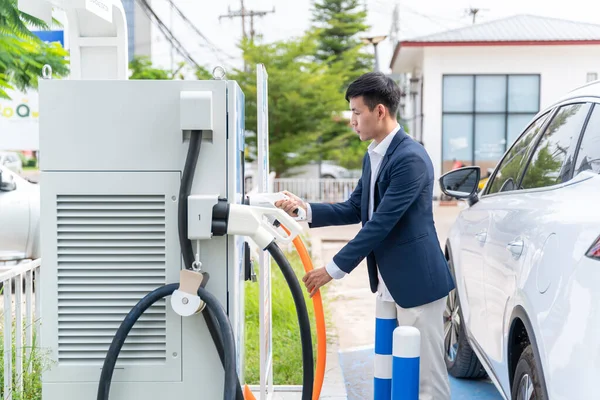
(309, 129), (454, 308)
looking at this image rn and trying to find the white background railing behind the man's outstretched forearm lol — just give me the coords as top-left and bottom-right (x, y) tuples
(273, 178), (358, 203)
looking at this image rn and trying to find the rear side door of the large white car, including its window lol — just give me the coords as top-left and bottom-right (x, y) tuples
(484, 102), (591, 382)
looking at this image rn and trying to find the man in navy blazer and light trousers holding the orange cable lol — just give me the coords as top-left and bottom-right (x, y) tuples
(277, 73), (454, 400)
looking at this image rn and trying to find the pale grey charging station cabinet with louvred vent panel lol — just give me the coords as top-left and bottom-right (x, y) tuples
(40, 80), (246, 400)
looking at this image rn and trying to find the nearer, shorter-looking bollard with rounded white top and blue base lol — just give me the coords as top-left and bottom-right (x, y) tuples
(392, 326), (421, 400)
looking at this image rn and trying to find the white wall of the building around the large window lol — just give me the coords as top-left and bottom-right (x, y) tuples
(423, 45), (600, 195)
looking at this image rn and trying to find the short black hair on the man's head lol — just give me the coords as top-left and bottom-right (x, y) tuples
(346, 72), (401, 116)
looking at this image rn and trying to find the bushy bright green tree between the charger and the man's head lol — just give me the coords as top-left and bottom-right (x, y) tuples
(228, 32), (347, 174)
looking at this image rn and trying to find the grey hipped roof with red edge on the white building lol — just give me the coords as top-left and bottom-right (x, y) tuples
(391, 14), (600, 66)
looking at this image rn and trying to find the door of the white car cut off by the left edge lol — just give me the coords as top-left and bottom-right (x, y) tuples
(0, 167), (29, 261)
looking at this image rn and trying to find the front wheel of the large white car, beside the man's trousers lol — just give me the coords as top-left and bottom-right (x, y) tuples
(444, 261), (487, 379)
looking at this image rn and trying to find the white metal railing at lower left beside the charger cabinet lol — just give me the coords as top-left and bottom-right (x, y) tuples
(0, 259), (41, 400)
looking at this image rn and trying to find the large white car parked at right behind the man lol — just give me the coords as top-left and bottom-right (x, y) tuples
(440, 82), (600, 400)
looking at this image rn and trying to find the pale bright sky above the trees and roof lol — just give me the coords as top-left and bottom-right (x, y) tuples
(151, 0), (600, 76)
